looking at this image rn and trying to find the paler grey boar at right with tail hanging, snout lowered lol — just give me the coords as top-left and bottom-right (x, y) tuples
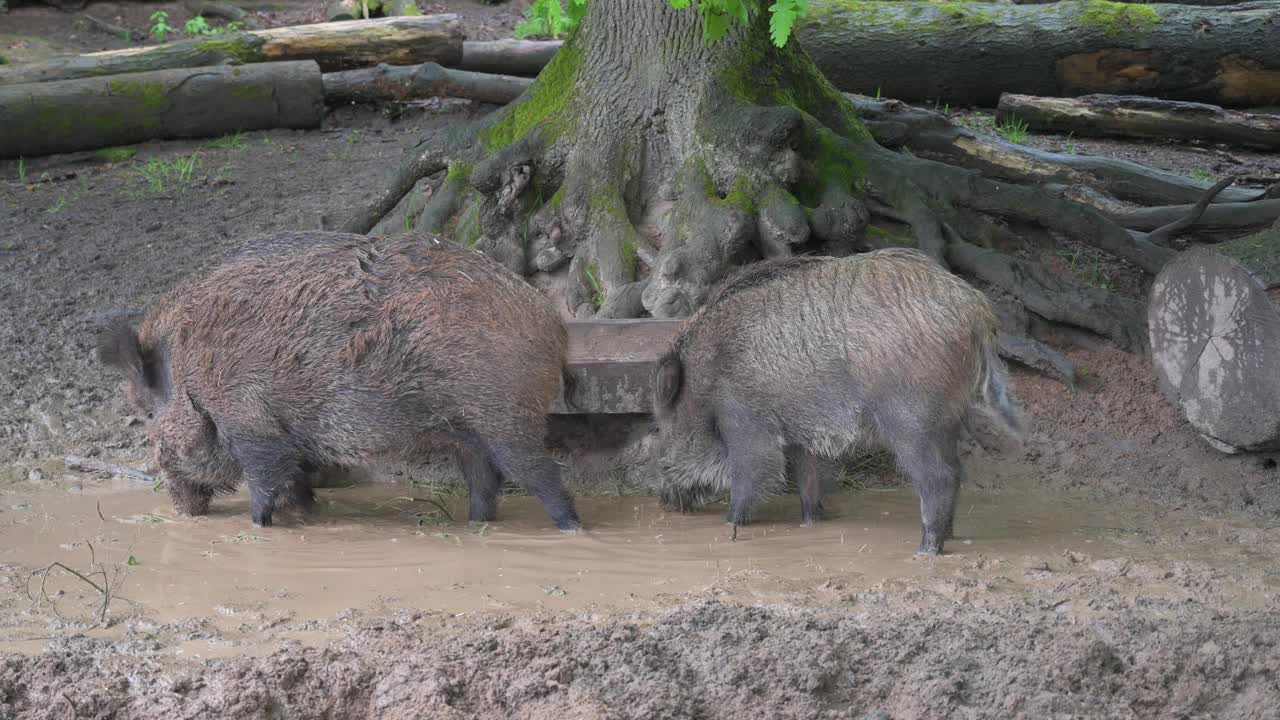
(654, 249), (1021, 555)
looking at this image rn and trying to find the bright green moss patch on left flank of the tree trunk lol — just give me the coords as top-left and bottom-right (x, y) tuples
(480, 40), (581, 151)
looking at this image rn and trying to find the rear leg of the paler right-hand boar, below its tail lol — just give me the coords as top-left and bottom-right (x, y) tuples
(893, 432), (960, 555)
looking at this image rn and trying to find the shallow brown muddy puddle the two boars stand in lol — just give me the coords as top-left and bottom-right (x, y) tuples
(0, 476), (1271, 653)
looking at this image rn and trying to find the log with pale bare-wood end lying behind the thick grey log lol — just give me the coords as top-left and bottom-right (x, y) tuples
(0, 15), (463, 86)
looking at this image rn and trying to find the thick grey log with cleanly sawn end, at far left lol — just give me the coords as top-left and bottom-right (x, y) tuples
(0, 60), (324, 158)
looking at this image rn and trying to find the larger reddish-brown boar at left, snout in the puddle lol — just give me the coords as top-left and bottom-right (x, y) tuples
(97, 232), (579, 532)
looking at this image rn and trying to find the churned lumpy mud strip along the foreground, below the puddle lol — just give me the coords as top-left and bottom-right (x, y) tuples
(0, 597), (1280, 720)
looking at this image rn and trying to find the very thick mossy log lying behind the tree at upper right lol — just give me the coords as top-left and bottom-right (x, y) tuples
(795, 0), (1280, 108)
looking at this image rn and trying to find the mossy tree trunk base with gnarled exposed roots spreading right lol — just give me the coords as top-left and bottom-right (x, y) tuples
(344, 0), (1259, 376)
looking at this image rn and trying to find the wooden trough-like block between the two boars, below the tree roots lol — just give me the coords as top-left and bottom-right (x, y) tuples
(552, 319), (682, 415)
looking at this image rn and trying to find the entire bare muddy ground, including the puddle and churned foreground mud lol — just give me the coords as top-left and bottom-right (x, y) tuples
(0, 0), (1280, 720)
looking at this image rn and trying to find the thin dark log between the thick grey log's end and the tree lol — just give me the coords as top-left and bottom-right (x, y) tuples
(324, 63), (534, 105)
